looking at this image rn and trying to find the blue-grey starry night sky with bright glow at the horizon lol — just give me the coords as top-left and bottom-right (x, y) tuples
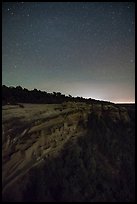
(2, 2), (135, 102)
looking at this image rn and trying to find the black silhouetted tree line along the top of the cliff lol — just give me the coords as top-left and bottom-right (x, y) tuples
(2, 85), (113, 105)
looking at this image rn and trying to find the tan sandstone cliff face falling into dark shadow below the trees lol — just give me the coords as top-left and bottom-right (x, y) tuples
(2, 103), (135, 202)
